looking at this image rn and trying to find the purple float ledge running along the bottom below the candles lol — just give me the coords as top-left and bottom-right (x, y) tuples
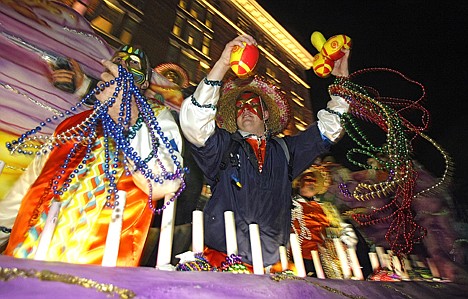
(0, 256), (468, 299)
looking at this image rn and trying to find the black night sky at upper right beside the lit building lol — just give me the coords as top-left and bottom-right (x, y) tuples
(257, 0), (468, 217)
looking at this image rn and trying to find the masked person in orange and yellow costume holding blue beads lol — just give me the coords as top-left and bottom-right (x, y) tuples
(2, 45), (184, 266)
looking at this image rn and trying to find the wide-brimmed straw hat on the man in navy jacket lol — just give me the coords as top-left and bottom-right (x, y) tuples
(216, 76), (291, 134)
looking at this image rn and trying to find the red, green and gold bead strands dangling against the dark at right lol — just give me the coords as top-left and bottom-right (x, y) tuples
(329, 68), (452, 257)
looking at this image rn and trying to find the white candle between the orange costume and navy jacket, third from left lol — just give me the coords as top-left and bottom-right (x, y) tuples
(156, 193), (176, 270)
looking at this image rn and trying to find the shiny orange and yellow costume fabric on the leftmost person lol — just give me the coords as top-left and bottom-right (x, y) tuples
(5, 110), (162, 266)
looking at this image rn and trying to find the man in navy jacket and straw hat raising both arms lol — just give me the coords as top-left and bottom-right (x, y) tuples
(180, 35), (349, 267)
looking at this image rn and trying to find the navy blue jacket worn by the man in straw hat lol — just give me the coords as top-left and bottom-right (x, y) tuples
(192, 124), (331, 266)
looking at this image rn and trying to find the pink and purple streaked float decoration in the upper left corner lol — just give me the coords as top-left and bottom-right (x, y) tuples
(0, 1), (113, 135)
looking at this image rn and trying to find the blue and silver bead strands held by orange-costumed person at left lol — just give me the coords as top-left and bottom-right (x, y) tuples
(6, 65), (187, 216)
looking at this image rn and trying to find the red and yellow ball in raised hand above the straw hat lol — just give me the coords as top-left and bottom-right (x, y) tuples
(229, 43), (259, 78)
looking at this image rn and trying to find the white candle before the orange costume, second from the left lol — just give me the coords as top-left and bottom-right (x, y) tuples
(101, 190), (127, 267)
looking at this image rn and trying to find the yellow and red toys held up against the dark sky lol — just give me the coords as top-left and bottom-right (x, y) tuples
(310, 31), (351, 78)
